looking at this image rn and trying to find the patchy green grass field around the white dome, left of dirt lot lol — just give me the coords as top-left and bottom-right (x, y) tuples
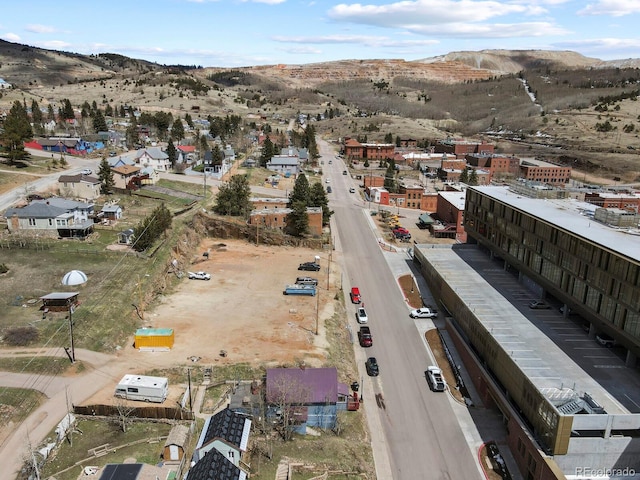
(0, 190), (199, 351)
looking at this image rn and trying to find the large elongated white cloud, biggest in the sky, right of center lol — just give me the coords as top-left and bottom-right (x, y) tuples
(328, 0), (547, 28)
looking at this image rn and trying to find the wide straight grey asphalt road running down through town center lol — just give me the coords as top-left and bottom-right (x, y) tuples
(318, 142), (482, 480)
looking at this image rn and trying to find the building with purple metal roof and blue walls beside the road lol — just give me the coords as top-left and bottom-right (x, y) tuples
(265, 367), (349, 434)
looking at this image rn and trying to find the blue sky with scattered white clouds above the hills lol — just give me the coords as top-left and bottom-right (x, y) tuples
(0, 0), (640, 67)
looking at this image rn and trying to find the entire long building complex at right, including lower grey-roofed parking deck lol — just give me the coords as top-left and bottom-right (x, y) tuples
(414, 187), (640, 480)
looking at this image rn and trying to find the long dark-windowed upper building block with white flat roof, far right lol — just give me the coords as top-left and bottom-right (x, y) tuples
(465, 187), (640, 367)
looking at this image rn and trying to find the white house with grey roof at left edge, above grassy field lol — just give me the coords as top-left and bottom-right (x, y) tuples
(5, 197), (94, 238)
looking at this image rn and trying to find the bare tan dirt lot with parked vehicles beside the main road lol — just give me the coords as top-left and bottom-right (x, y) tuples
(87, 239), (340, 403)
